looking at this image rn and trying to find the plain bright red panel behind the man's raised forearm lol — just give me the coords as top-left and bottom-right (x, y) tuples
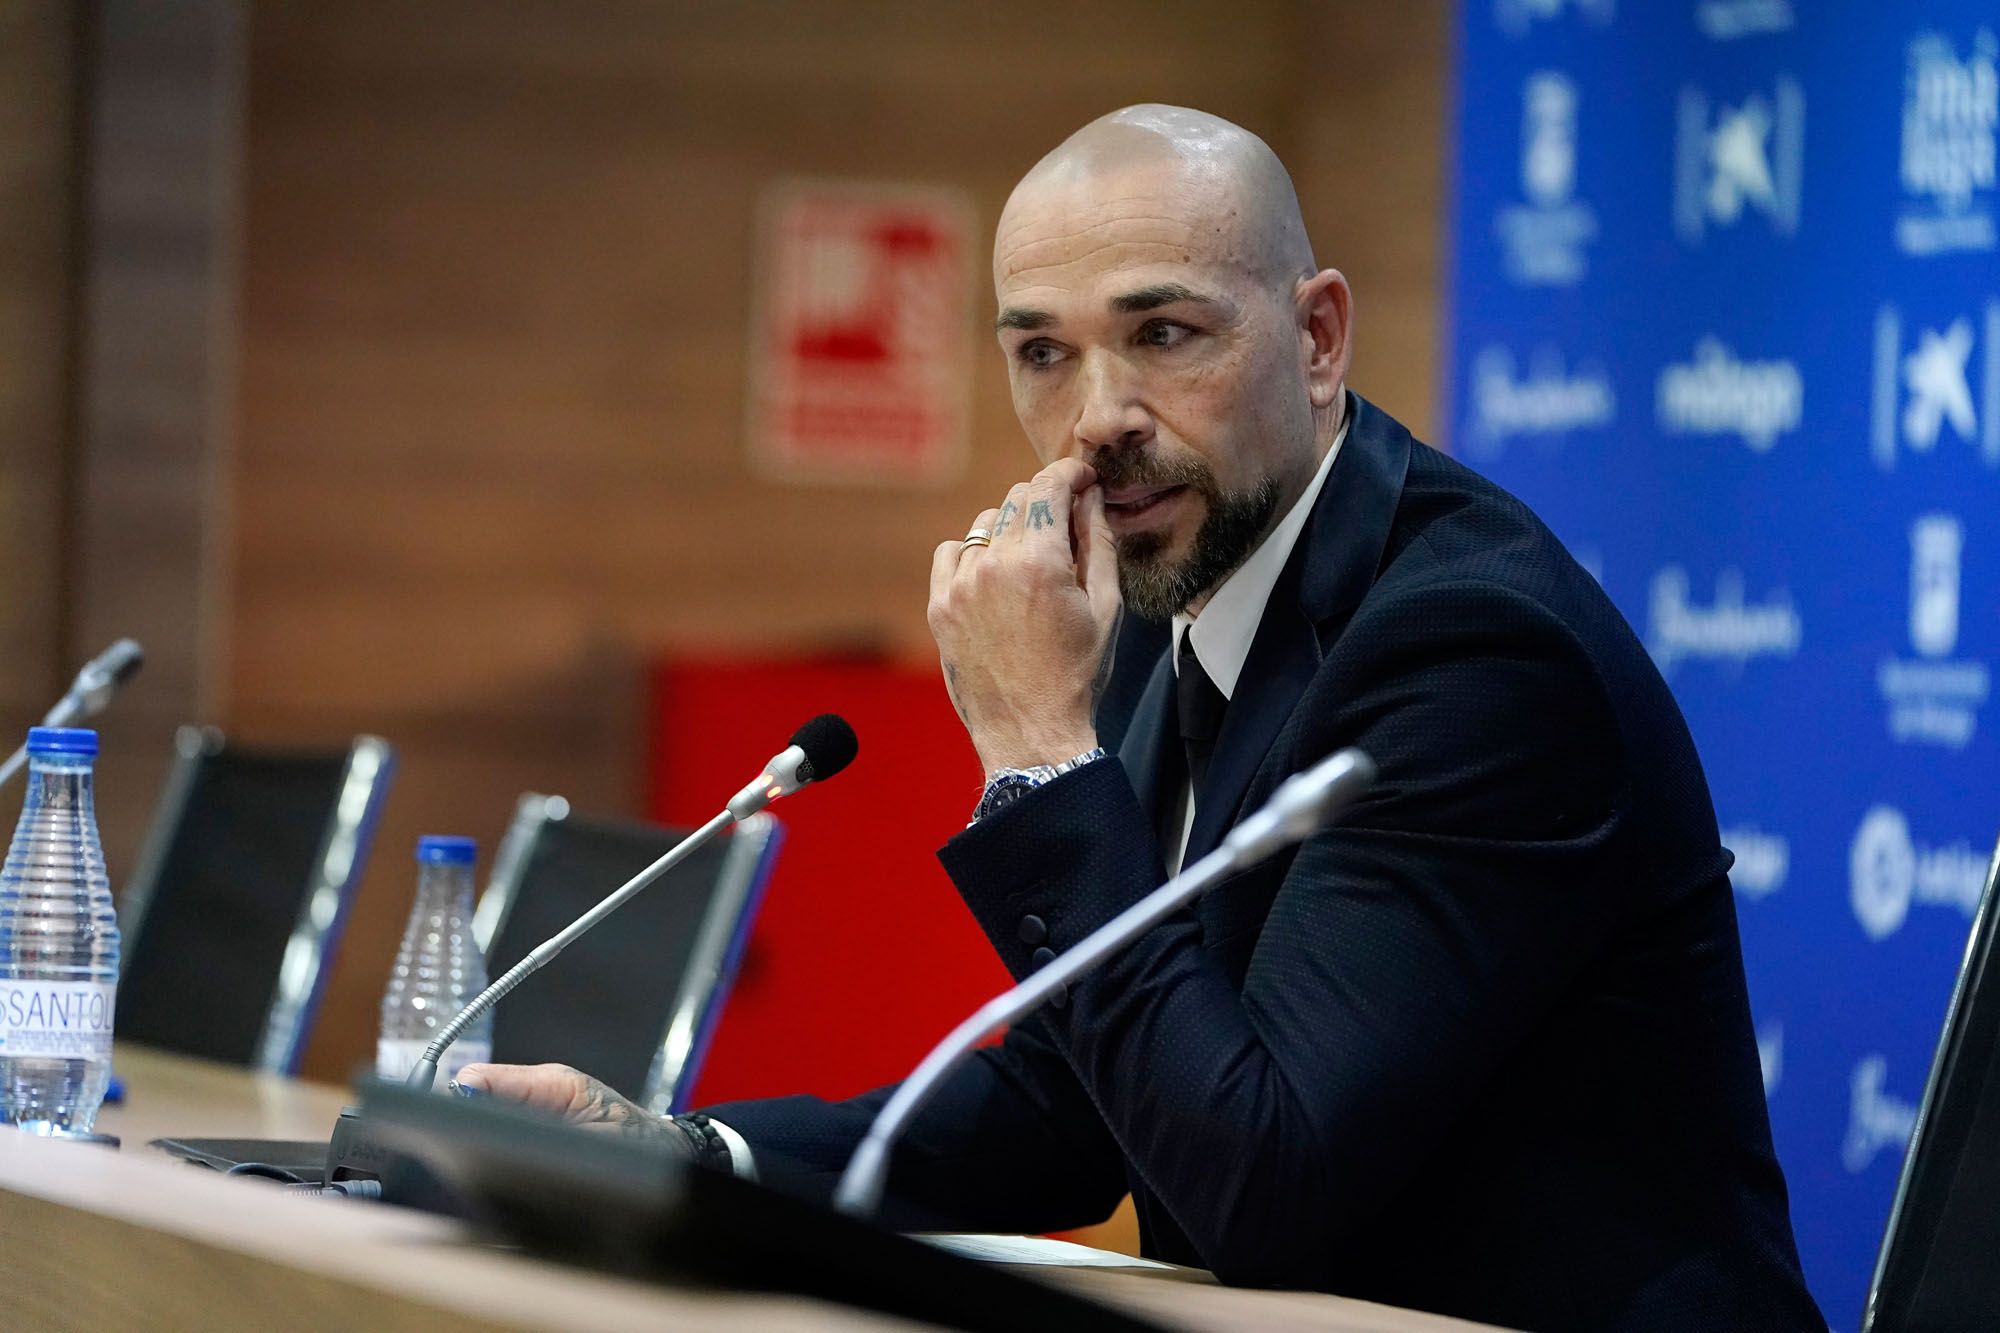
(650, 656), (1008, 1105)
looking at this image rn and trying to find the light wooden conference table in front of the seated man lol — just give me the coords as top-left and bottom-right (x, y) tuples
(0, 1047), (1504, 1333)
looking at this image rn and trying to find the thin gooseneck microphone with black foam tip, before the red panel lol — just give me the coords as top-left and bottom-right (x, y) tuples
(408, 713), (860, 1091)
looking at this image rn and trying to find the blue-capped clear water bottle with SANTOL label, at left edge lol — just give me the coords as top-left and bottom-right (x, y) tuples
(0, 727), (118, 1135)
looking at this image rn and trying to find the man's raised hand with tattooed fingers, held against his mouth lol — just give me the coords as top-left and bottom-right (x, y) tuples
(930, 458), (1122, 773)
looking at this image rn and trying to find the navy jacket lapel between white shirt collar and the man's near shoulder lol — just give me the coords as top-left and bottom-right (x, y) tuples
(1176, 394), (1410, 865)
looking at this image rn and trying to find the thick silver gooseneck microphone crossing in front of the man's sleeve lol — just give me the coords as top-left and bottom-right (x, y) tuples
(834, 749), (1376, 1217)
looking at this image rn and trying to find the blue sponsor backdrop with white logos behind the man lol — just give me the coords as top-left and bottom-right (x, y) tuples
(1448, 0), (2000, 1329)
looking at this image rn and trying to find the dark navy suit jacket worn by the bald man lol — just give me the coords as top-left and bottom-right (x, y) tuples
(712, 398), (1824, 1333)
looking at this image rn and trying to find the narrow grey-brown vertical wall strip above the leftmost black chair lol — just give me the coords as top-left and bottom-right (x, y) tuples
(62, 0), (242, 872)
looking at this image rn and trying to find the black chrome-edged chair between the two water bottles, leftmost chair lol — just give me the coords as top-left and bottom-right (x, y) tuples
(118, 727), (396, 1073)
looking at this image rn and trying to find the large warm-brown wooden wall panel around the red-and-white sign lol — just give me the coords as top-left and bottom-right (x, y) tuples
(228, 0), (1442, 1073)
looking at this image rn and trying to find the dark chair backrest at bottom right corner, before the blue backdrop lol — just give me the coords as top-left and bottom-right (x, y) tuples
(1862, 832), (2000, 1333)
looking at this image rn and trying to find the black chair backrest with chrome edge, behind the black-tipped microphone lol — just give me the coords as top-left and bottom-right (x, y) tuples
(472, 795), (778, 1111)
